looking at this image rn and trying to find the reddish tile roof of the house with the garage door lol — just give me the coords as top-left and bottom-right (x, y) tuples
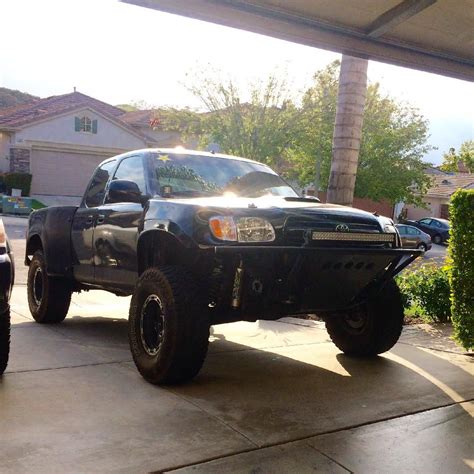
(0, 92), (123, 128)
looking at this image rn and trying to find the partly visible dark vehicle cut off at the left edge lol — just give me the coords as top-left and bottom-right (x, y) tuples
(0, 219), (15, 375)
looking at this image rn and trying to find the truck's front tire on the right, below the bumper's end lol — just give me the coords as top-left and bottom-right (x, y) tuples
(325, 280), (404, 357)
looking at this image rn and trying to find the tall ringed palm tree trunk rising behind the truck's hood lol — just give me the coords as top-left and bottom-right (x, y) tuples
(327, 55), (368, 206)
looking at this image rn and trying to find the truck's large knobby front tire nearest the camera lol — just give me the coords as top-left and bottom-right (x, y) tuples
(128, 266), (210, 384)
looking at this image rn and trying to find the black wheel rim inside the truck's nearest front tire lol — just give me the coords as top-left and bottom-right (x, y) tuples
(140, 295), (165, 356)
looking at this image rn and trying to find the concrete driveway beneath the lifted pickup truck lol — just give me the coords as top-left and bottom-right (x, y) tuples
(0, 217), (474, 473)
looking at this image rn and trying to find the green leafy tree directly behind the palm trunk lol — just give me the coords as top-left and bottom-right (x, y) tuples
(290, 62), (432, 203)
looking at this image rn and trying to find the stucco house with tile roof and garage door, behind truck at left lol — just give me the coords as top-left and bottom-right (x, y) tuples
(0, 91), (189, 202)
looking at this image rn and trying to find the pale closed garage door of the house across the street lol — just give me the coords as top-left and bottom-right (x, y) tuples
(31, 149), (113, 196)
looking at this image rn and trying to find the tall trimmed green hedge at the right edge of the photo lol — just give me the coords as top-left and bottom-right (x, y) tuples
(448, 189), (474, 350)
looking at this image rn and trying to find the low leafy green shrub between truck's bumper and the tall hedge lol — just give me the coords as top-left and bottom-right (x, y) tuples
(397, 265), (451, 323)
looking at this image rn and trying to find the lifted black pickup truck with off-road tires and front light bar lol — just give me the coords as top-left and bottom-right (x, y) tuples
(26, 149), (421, 383)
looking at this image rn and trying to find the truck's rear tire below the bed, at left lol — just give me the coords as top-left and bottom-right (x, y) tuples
(27, 250), (72, 324)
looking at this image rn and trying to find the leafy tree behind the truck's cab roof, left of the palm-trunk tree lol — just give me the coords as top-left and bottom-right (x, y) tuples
(182, 75), (298, 169)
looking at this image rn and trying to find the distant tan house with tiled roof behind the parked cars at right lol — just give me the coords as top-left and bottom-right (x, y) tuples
(405, 173), (474, 220)
